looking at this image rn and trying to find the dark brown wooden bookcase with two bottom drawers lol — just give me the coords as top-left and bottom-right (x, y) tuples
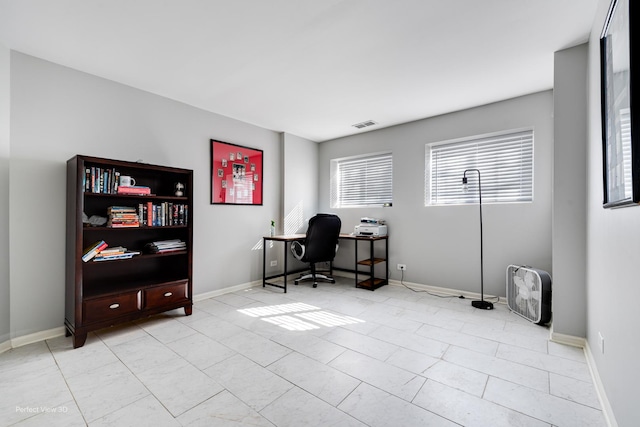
(65, 155), (193, 348)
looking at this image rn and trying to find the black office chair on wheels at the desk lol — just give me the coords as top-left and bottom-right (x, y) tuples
(291, 214), (342, 288)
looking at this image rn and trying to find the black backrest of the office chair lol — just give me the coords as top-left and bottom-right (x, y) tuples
(302, 214), (342, 263)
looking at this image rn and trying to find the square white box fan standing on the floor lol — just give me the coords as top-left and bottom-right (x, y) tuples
(507, 265), (551, 325)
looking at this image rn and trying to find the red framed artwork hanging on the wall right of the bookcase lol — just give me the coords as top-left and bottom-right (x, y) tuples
(211, 139), (263, 205)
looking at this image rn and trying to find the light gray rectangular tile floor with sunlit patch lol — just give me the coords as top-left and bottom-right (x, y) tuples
(0, 278), (606, 427)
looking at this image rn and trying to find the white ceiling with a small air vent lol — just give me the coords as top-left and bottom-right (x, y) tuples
(0, 0), (597, 141)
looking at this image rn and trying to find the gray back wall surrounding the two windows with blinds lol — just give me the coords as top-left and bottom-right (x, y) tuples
(318, 91), (553, 296)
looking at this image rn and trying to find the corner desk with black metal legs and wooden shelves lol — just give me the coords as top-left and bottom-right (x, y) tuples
(262, 234), (389, 293)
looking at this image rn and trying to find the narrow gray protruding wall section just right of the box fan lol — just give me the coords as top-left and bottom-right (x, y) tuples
(552, 44), (588, 337)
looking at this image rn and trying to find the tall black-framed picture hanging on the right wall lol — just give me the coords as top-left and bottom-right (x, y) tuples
(600, 0), (640, 208)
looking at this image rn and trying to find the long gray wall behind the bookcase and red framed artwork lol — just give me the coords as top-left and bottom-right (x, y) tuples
(8, 52), (281, 337)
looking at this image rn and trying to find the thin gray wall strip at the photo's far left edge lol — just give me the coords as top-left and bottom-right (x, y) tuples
(0, 44), (11, 345)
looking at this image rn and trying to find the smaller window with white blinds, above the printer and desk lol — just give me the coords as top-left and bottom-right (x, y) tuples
(331, 153), (393, 208)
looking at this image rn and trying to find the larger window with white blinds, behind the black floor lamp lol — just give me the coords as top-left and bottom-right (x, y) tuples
(425, 129), (533, 205)
